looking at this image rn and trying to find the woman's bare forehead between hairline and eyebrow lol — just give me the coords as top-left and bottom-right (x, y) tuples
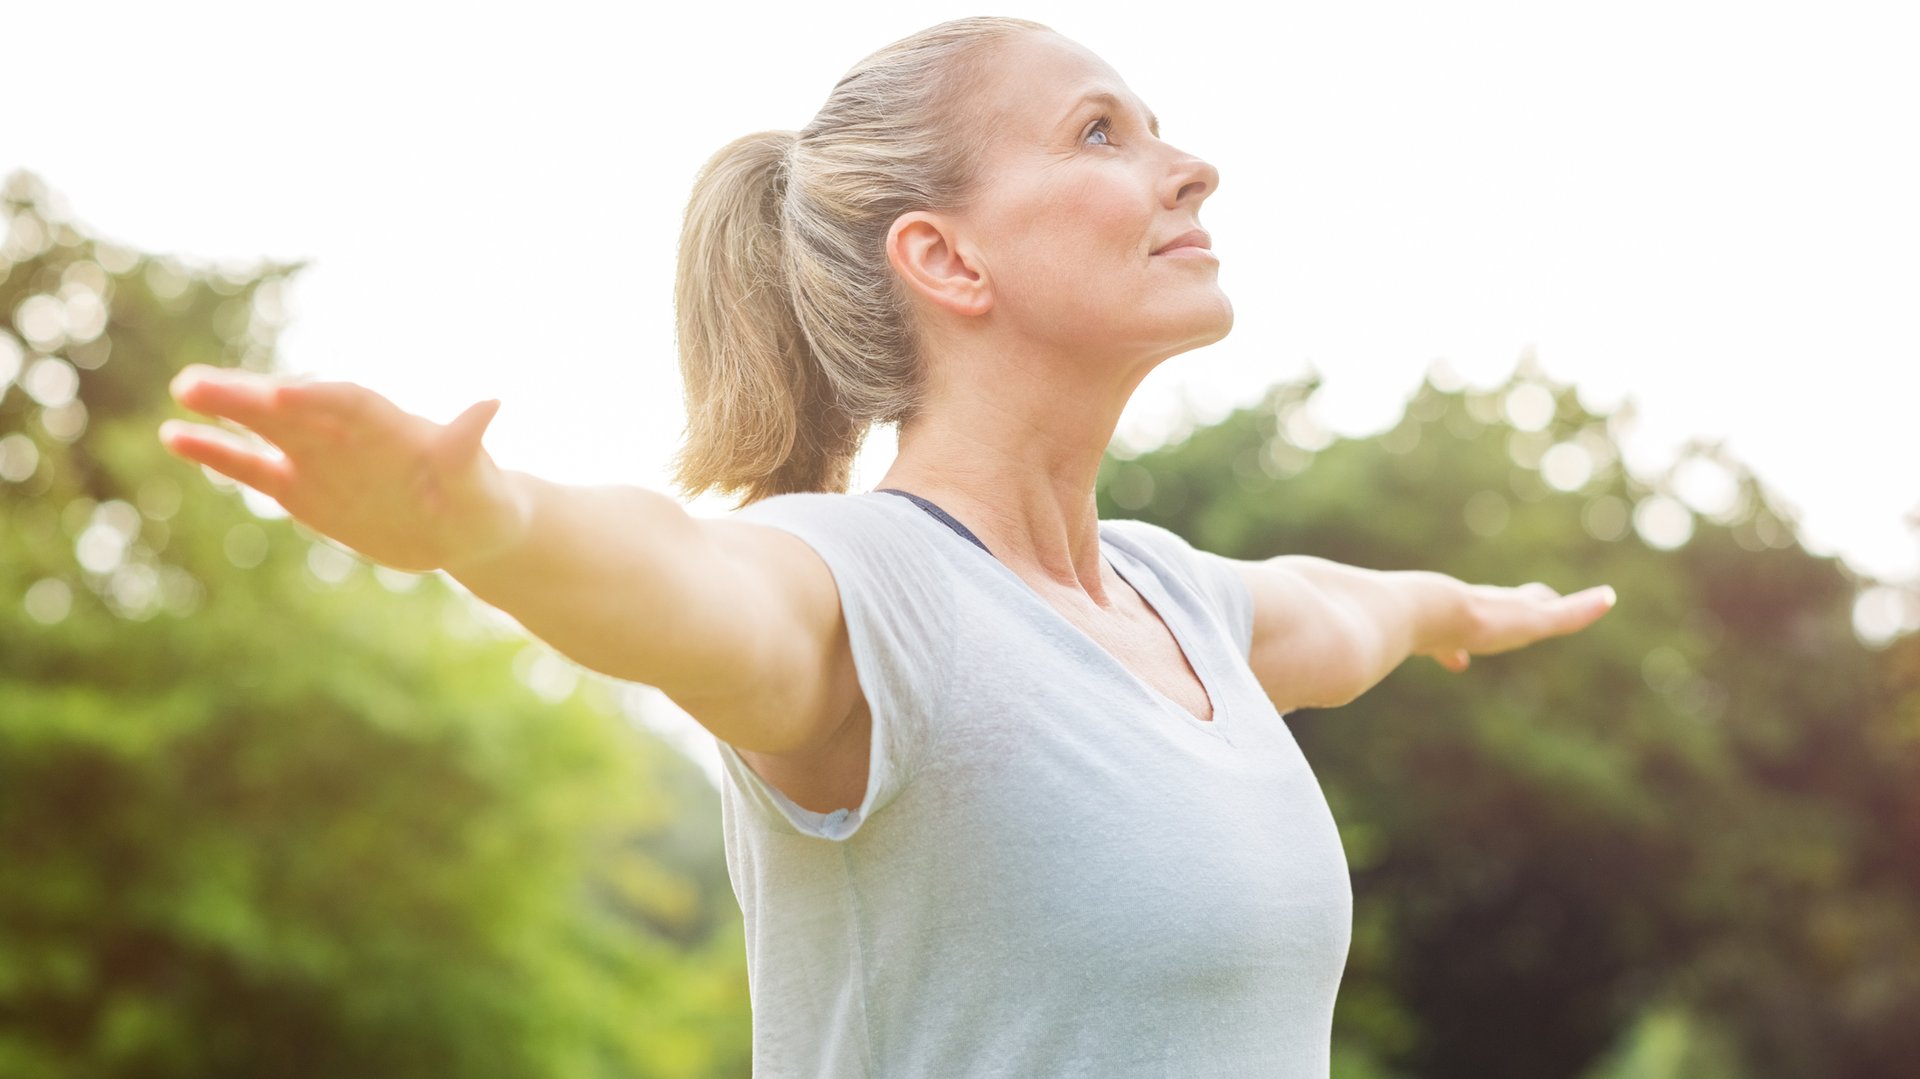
(979, 33), (1158, 138)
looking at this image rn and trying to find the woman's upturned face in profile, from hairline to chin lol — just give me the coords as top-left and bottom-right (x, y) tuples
(960, 33), (1233, 361)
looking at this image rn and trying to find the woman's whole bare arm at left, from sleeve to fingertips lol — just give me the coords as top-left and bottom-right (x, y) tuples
(161, 365), (858, 755)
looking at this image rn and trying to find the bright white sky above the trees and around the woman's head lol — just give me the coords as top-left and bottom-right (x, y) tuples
(0, 0), (1920, 578)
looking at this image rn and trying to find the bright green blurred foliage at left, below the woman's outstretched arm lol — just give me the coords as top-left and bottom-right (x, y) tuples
(0, 173), (749, 1079)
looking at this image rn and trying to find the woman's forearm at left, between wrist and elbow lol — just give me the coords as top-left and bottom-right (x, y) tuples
(445, 470), (701, 685)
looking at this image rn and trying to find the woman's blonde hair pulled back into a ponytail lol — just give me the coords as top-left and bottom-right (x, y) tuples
(672, 17), (1048, 505)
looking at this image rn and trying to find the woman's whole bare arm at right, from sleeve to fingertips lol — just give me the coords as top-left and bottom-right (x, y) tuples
(1229, 555), (1615, 714)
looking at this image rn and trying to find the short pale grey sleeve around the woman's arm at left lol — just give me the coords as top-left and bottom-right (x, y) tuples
(716, 492), (954, 841)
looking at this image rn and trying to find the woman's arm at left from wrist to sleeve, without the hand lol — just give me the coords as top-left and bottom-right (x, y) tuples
(447, 472), (858, 756)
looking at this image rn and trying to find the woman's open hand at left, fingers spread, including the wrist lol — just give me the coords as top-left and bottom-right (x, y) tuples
(159, 363), (528, 572)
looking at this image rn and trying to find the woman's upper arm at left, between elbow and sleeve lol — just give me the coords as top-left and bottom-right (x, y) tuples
(657, 518), (860, 756)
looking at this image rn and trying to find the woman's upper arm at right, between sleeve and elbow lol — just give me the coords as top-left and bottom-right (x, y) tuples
(1235, 557), (1380, 714)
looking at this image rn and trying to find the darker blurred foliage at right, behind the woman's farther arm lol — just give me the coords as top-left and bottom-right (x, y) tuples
(1100, 357), (1920, 1079)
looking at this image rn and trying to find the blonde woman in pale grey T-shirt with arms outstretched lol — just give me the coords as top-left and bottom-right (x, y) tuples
(161, 19), (1613, 1077)
